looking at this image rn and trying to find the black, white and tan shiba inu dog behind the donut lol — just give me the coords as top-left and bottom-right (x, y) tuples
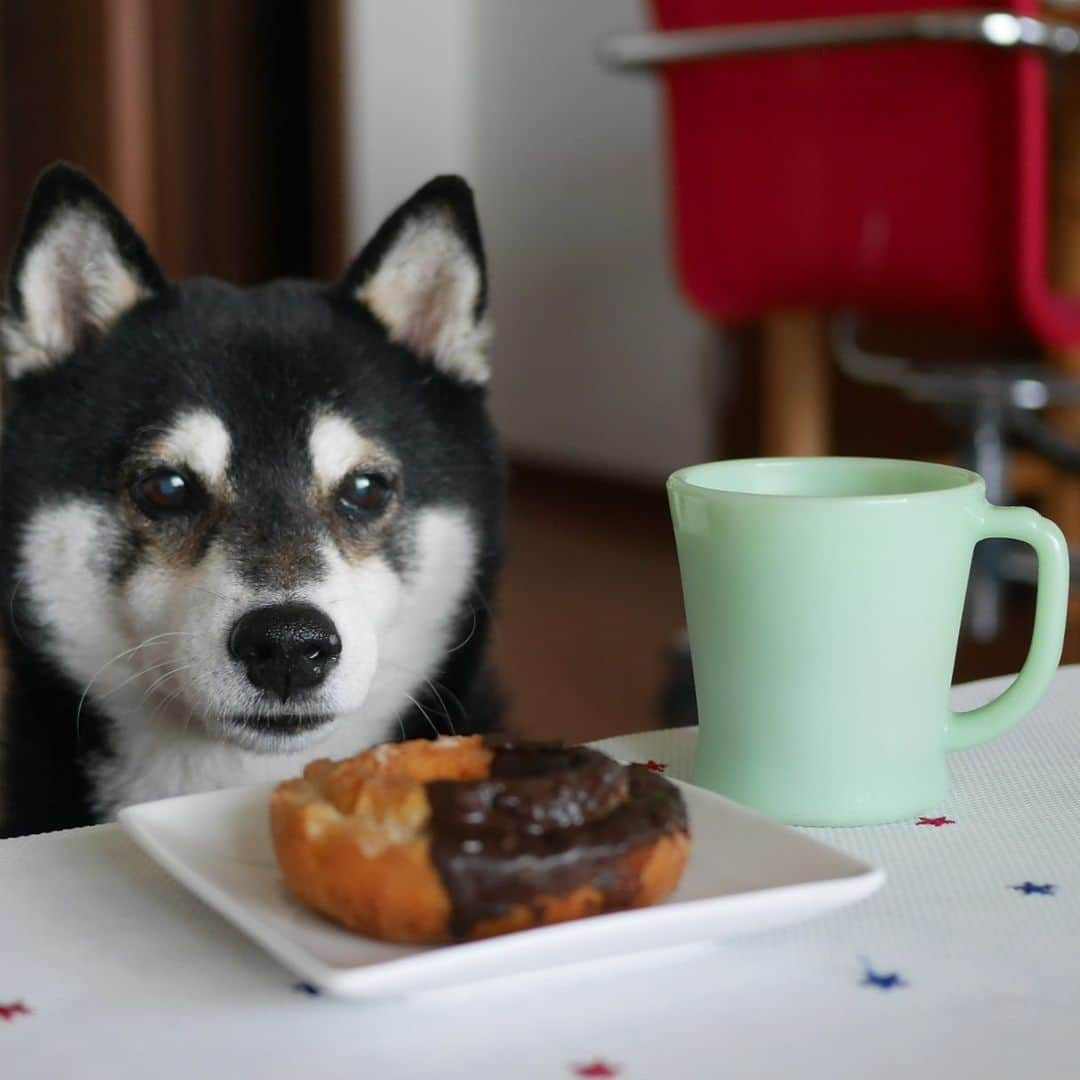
(0, 165), (503, 835)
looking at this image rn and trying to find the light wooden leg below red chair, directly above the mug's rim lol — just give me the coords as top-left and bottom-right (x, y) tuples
(761, 311), (832, 457)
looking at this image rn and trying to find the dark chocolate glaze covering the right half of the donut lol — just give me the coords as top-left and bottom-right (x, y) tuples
(427, 742), (687, 937)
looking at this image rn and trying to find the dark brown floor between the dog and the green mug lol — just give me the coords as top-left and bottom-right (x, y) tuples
(494, 468), (1080, 741)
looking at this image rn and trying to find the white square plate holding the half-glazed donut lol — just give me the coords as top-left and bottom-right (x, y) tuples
(120, 729), (885, 997)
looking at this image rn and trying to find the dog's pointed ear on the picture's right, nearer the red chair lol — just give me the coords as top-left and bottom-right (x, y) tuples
(345, 176), (491, 384)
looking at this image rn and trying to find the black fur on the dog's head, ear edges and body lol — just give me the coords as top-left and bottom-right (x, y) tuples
(0, 166), (503, 835)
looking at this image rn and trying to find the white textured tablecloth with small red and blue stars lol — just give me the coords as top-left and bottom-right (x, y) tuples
(0, 669), (1080, 1080)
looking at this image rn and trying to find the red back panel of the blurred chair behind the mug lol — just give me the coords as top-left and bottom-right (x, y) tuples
(651, 0), (1080, 345)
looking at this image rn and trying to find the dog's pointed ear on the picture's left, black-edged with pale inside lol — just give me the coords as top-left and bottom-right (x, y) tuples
(0, 164), (165, 378)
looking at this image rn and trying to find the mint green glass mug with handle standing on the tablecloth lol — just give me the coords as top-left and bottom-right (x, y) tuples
(667, 458), (1069, 825)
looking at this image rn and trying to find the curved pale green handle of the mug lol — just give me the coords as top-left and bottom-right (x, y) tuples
(945, 503), (1069, 751)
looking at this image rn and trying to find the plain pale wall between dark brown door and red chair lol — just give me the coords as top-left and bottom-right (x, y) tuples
(346, 0), (713, 478)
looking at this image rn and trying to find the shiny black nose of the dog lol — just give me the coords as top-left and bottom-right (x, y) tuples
(229, 604), (341, 701)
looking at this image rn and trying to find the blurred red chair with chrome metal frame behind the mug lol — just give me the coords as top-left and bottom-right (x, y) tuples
(600, 0), (1080, 637)
